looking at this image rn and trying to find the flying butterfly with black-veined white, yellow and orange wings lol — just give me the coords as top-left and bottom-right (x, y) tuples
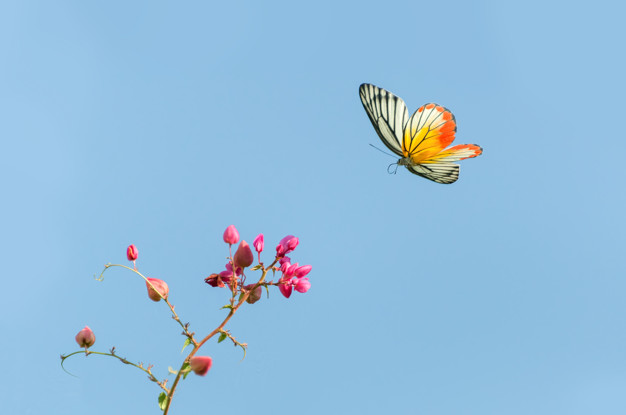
(359, 84), (483, 184)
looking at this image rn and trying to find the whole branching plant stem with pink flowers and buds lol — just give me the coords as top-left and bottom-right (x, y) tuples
(61, 225), (312, 415)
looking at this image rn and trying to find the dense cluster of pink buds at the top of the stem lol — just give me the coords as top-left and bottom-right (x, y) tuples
(205, 225), (312, 303)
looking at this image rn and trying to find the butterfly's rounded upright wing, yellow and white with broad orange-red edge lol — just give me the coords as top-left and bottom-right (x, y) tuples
(402, 103), (456, 164)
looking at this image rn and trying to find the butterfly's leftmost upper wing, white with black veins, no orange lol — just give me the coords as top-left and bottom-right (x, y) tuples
(359, 84), (409, 156)
